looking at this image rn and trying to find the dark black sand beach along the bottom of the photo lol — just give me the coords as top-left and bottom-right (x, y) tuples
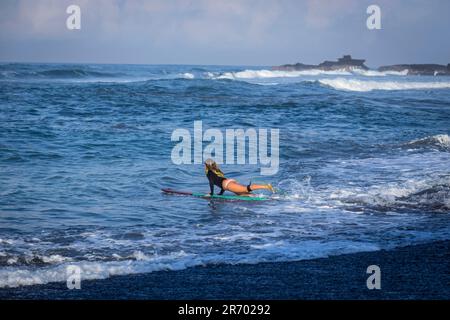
(0, 241), (450, 300)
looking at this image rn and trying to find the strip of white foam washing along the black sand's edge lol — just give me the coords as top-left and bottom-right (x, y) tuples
(0, 241), (379, 288)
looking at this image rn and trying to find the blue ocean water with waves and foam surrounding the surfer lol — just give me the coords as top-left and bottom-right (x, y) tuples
(0, 64), (450, 287)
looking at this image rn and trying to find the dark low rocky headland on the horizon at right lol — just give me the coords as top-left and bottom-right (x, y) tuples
(272, 55), (450, 76)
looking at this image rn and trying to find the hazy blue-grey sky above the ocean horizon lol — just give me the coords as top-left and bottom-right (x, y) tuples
(0, 0), (450, 67)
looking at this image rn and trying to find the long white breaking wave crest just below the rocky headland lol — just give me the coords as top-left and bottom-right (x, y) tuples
(319, 78), (450, 92)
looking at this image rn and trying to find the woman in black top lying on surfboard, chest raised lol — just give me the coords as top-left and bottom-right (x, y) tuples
(205, 159), (275, 196)
